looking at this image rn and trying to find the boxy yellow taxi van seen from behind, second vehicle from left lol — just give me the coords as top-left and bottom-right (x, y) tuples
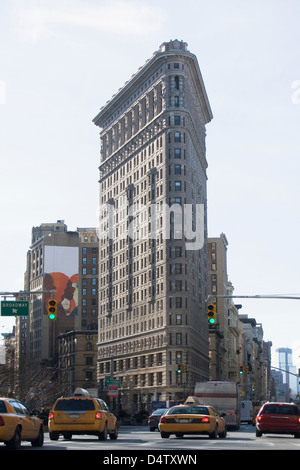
(48, 394), (118, 441)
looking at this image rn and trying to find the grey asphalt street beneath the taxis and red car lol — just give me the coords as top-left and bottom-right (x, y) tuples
(0, 424), (300, 456)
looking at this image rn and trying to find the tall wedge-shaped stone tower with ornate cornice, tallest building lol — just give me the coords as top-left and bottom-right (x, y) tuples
(94, 40), (212, 411)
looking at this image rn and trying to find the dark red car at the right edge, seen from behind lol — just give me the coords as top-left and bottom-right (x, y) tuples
(256, 402), (300, 438)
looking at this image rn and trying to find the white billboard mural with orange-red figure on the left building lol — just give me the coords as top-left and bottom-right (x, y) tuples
(44, 246), (79, 316)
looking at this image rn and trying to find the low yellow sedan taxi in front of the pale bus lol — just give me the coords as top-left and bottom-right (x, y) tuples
(158, 405), (227, 439)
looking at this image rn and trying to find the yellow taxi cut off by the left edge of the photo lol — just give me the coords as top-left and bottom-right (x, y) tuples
(0, 397), (44, 449)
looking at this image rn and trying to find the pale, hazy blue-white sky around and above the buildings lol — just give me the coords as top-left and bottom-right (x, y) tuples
(0, 0), (300, 367)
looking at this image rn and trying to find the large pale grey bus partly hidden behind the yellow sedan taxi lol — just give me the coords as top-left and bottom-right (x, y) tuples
(194, 381), (241, 429)
